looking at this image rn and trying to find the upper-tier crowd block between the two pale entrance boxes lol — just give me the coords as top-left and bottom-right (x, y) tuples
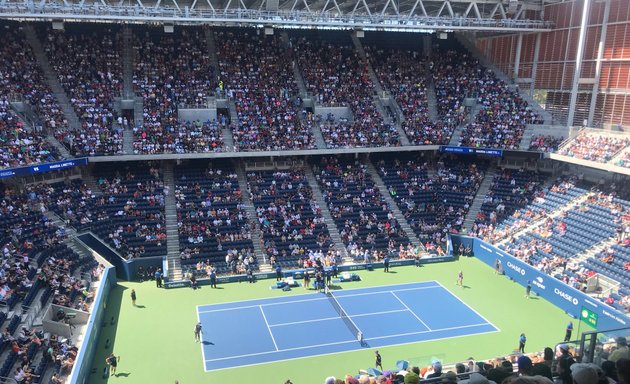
(215, 30), (316, 151)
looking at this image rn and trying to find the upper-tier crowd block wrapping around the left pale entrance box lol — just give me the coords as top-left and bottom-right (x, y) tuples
(133, 28), (224, 154)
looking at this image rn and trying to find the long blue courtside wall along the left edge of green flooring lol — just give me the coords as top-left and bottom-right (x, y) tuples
(68, 267), (116, 384)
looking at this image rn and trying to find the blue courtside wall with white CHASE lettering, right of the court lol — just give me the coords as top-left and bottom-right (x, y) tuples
(454, 234), (630, 330)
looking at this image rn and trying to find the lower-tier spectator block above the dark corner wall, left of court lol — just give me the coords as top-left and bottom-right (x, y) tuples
(30, 163), (166, 259)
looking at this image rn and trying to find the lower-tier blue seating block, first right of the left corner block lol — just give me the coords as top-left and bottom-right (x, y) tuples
(175, 162), (258, 276)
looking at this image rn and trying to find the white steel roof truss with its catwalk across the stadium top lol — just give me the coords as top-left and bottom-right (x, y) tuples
(0, 0), (553, 33)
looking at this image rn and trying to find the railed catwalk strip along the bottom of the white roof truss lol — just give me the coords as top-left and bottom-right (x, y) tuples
(0, 0), (553, 32)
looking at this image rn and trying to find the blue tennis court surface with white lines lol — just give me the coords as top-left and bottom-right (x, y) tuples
(197, 281), (498, 371)
